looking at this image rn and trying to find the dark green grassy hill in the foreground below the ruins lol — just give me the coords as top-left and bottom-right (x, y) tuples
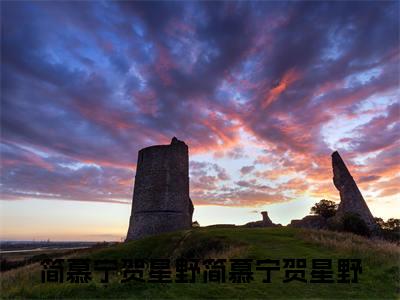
(1, 227), (400, 299)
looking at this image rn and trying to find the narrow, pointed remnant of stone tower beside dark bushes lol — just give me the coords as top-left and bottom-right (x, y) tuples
(332, 151), (377, 230)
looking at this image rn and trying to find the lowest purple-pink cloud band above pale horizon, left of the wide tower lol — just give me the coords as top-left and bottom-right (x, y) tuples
(1, 144), (134, 203)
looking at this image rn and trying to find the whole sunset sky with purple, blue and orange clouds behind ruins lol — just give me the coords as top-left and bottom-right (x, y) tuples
(0, 1), (400, 241)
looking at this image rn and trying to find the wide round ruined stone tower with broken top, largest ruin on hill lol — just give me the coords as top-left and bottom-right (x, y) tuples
(126, 137), (193, 241)
